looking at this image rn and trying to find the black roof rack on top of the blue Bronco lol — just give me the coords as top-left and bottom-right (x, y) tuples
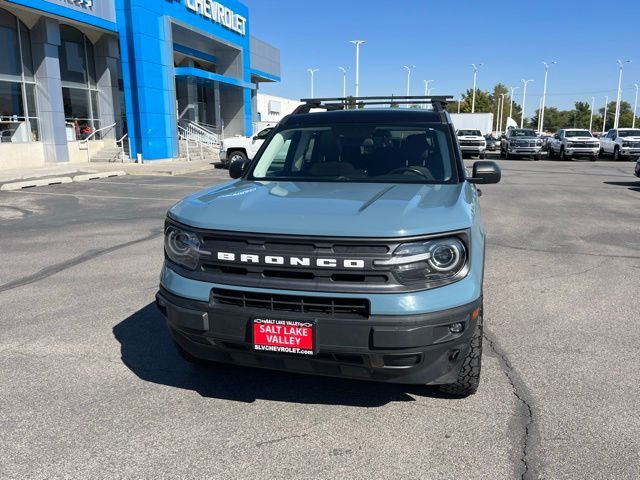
(293, 95), (453, 115)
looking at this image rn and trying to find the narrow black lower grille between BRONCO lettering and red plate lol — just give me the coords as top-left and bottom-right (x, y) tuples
(212, 288), (370, 318)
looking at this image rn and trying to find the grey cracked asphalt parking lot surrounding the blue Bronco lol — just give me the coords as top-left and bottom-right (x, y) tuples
(0, 160), (640, 479)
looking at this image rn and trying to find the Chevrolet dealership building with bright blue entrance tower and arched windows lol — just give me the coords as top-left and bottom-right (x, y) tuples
(0, 0), (280, 169)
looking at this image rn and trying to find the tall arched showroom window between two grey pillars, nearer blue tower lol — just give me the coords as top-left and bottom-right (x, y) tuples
(60, 25), (100, 141)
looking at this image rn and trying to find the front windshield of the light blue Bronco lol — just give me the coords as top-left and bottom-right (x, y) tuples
(249, 124), (457, 183)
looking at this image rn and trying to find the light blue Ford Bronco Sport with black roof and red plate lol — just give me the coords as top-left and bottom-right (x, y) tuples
(156, 97), (501, 396)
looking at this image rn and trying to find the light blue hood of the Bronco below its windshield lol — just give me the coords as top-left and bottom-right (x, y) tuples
(169, 180), (476, 237)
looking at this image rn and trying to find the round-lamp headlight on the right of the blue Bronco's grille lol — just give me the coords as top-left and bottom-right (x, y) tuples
(375, 237), (467, 286)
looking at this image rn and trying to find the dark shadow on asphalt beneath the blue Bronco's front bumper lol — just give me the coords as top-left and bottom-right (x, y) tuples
(113, 303), (452, 407)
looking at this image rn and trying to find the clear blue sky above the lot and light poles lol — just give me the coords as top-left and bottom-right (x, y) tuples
(244, 0), (640, 115)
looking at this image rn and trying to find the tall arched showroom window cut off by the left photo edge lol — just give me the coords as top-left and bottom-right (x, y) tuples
(0, 9), (38, 143)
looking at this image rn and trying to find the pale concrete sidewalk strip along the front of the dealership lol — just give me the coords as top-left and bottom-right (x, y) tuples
(0, 161), (220, 185)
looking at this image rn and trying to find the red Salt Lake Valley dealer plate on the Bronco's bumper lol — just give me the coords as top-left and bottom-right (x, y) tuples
(253, 318), (315, 355)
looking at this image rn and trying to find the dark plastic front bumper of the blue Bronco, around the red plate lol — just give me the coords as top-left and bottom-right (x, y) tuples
(156, 287), (482, 384)
